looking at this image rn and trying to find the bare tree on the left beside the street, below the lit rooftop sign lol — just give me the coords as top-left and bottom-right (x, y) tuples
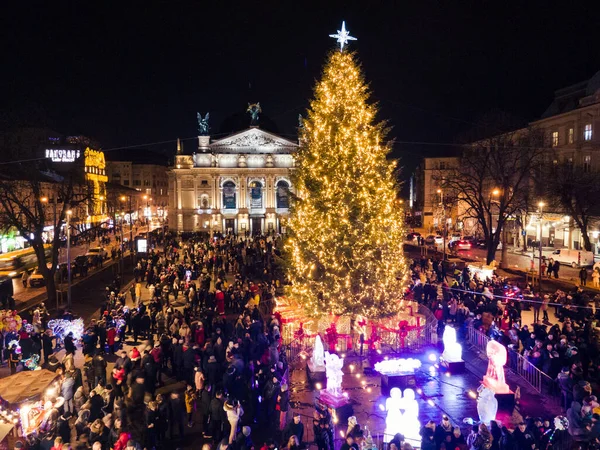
(0, 128), (91, 303)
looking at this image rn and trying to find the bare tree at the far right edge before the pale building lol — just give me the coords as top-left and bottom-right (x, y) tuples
(542, 159), (600, 251)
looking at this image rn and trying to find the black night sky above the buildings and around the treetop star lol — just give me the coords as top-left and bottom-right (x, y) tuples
(0, 0), (600, 183)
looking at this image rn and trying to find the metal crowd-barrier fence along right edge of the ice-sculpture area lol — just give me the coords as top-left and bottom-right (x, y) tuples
(467, 327), (561, 404)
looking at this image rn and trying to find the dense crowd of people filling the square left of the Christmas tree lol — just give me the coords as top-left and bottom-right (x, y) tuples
(1, 234), (333, 450)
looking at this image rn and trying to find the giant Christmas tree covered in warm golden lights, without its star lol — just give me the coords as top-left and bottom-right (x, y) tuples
(286, 51), (407, 318)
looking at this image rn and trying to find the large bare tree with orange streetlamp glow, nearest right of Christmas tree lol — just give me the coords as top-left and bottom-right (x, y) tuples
(438, 130), (543, 264)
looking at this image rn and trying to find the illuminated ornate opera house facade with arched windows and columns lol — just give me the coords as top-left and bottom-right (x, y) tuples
(168, 126), (298, 234)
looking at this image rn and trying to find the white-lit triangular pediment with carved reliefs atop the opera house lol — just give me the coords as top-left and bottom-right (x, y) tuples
(210, 128), (298, 153)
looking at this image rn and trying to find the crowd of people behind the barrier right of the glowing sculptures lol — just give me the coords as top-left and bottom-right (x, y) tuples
(411, 259), (600, 450)
